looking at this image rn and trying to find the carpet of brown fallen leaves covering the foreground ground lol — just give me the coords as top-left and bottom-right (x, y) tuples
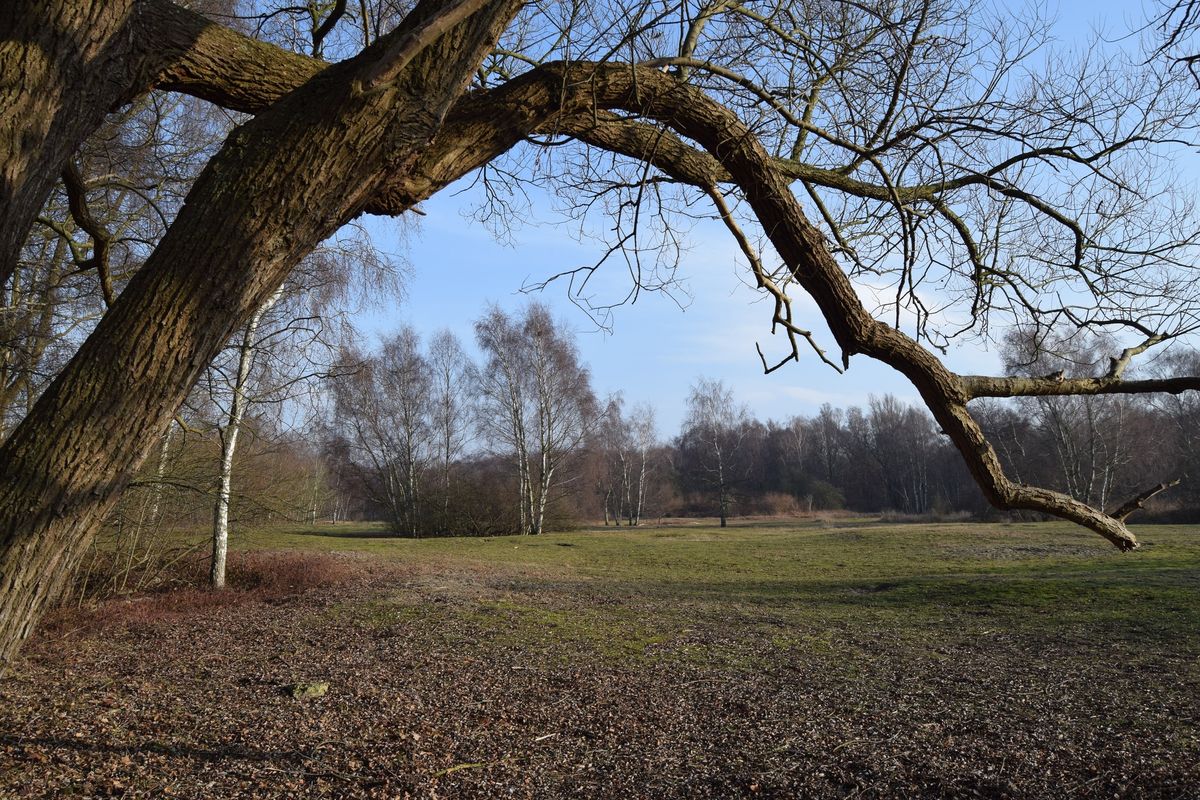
(0, 551), (1200, 800)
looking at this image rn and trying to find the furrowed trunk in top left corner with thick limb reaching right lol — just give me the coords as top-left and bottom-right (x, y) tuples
(0, 0), (297, 287)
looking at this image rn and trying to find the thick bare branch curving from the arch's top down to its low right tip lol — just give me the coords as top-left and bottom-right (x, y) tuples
(420, 64), (1152, 549)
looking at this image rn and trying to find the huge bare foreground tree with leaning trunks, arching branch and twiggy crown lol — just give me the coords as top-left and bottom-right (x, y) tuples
(0, 0), (1200, 660)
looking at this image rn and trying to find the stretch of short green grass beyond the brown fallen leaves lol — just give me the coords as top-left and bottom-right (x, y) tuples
(231, 522), (1200, 666)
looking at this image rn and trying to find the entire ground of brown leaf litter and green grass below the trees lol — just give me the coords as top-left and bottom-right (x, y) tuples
(0, 521), (1200, 799)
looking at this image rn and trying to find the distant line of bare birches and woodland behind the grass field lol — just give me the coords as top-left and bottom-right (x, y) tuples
(110, 303), (1200, 569)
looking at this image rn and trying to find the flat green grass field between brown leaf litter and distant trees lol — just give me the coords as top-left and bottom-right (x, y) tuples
(241, 522), (1200, 645)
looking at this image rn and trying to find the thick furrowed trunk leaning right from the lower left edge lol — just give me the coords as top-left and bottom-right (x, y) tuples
(0, 0), (520, 662)
